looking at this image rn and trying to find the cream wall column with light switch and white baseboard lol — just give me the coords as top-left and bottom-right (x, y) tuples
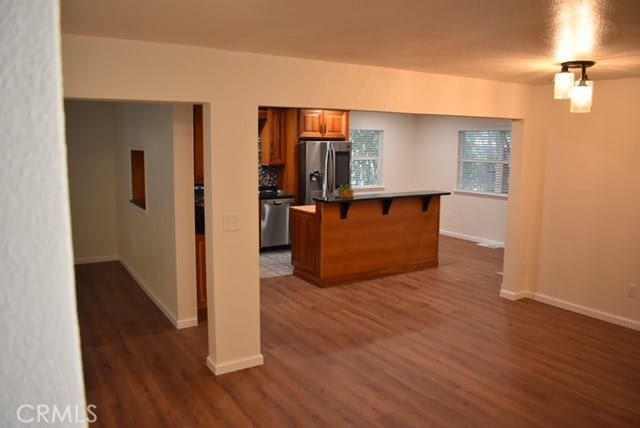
(204, 99), (263, 374)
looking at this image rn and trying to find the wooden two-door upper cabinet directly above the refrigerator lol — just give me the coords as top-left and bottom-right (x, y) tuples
(298, 109), (349, 140)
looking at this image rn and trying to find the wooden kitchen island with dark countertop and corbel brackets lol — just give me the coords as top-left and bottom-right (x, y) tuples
(291, 190), (450, 287)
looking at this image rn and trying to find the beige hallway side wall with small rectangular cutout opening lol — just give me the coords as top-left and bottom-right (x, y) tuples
(114, 103), (197, 328)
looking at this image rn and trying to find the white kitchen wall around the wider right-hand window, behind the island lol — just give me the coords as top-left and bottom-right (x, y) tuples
(414, 116), (511, 246)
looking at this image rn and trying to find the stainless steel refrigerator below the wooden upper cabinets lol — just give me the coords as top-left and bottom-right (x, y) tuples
(299, 141), (351, 205)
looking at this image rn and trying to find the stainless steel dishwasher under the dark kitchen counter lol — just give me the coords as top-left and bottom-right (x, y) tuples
(260, 198), (294, 249)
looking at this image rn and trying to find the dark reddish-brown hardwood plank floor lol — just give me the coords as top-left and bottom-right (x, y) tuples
(76, 237), (640, 427)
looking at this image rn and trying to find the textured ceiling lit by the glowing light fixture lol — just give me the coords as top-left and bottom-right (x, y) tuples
(61, 0), (640, 84)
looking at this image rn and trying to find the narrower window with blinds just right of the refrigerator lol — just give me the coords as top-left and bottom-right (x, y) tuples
(351, 129), (383, 187)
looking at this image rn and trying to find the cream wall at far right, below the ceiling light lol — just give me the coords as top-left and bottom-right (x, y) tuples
(531, 79), (640, 328)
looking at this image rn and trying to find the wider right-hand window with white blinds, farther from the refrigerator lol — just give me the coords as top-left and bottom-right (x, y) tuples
(458, 130), (511, 195)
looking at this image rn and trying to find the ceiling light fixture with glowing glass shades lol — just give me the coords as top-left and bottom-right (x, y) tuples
(553, 61), (595, 113)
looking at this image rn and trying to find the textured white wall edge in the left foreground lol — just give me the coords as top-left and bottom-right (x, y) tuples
(0, 1), (85, 427)
